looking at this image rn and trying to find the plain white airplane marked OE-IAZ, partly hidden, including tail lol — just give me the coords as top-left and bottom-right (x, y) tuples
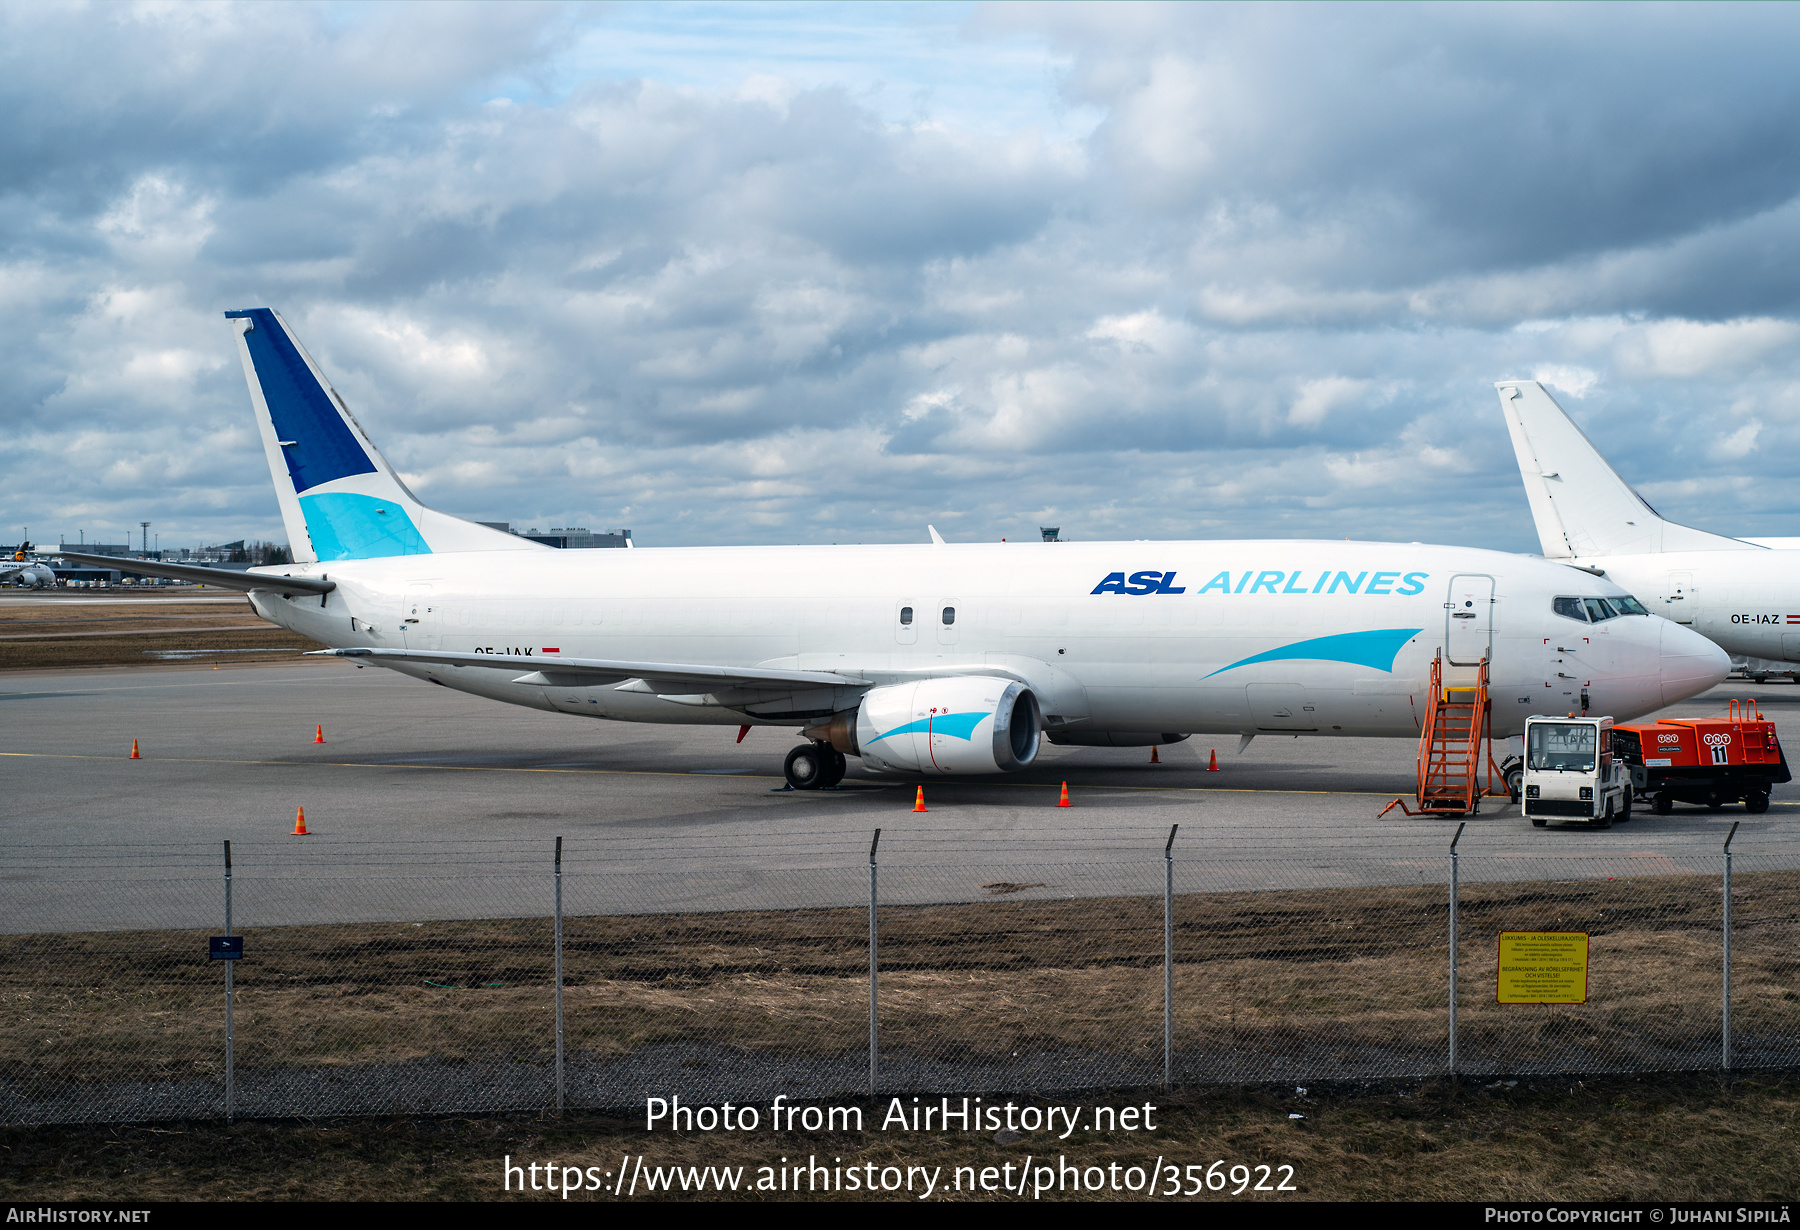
(1494, 380), (1800, 663)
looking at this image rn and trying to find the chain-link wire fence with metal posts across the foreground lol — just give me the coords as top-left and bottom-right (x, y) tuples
(0, 837), (1800, 1124)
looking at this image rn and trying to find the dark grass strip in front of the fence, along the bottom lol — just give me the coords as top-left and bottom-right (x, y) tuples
(0, 1077), (1800, 1201)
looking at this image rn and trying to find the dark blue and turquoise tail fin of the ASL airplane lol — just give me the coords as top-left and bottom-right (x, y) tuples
(225, 308), (536, 562)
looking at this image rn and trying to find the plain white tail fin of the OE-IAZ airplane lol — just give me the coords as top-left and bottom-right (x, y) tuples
(1494, 380), (1757, 560)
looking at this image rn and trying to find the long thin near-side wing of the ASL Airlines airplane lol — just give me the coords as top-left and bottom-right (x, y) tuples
(308, 648), (869, 695)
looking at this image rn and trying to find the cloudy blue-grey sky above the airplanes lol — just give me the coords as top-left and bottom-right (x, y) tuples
(0, 2), (1800, 551)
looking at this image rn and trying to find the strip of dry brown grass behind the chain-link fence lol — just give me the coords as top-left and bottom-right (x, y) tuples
(0, 873), (1800, 1082)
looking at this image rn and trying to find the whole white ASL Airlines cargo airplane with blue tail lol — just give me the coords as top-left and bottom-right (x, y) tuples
(73, 308), (1728, 789)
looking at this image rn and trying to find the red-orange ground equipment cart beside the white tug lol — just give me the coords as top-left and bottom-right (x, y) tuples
(1605, 701), (1793, 816)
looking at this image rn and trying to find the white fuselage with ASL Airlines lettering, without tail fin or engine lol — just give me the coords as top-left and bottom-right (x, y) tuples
(252, 540), (1728, 737)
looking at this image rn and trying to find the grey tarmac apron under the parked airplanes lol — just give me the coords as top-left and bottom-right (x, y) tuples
(0, 659), (1800, 933)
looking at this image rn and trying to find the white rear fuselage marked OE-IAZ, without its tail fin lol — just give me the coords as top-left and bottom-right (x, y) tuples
(1573, 549), (1800, 663)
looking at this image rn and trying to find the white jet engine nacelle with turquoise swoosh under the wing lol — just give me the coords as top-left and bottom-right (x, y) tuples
(853, 675), (1044, 774)
